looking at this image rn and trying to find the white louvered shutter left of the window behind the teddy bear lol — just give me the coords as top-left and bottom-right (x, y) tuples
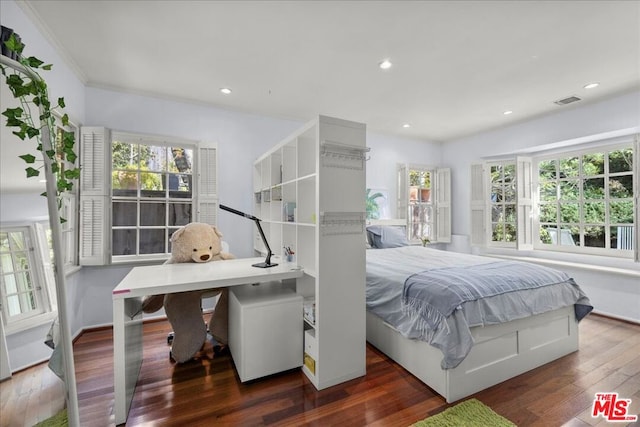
(78, 127), (111, 265)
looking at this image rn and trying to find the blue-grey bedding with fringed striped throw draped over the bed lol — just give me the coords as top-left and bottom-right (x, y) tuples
(366, 246), (593, 369)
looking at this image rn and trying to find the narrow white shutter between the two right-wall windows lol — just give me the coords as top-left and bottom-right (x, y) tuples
(516, 156), (533, 250)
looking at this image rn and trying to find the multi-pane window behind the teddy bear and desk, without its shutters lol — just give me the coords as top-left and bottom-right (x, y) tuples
(111, 134), (194, 257)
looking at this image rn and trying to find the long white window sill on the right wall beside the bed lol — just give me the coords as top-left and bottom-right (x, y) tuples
(481, 248), (640, 278)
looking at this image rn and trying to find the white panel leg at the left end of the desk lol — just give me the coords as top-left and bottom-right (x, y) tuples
(113, 298), (142, 425)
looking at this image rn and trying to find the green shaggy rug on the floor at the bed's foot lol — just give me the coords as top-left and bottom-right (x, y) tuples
(413, 399), (516, 427)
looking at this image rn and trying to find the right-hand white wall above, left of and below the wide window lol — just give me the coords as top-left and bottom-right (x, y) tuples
(442, 92), (640, 322)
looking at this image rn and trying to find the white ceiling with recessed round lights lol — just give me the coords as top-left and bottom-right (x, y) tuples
(1, 0), (640, 194)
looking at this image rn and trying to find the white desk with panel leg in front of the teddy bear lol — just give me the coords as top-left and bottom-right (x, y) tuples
(113, 258), (303, 424)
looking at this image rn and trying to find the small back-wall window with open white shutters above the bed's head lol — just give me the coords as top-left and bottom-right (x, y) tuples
(398, 165), (451, 242)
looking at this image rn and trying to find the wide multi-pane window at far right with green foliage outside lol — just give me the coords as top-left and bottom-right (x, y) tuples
(536, 144), (634, 254)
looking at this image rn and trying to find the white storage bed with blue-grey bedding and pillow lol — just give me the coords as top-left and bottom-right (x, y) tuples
(366, 226), (593, 402)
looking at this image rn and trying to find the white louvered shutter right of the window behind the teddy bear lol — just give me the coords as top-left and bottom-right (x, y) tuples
(196, 145), (218, 225)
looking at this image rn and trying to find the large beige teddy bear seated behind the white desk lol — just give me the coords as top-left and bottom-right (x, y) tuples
(142, 222), (235, 363)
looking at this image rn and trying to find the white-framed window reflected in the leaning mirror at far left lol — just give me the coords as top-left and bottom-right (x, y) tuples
(0, 226), (55, 330)
